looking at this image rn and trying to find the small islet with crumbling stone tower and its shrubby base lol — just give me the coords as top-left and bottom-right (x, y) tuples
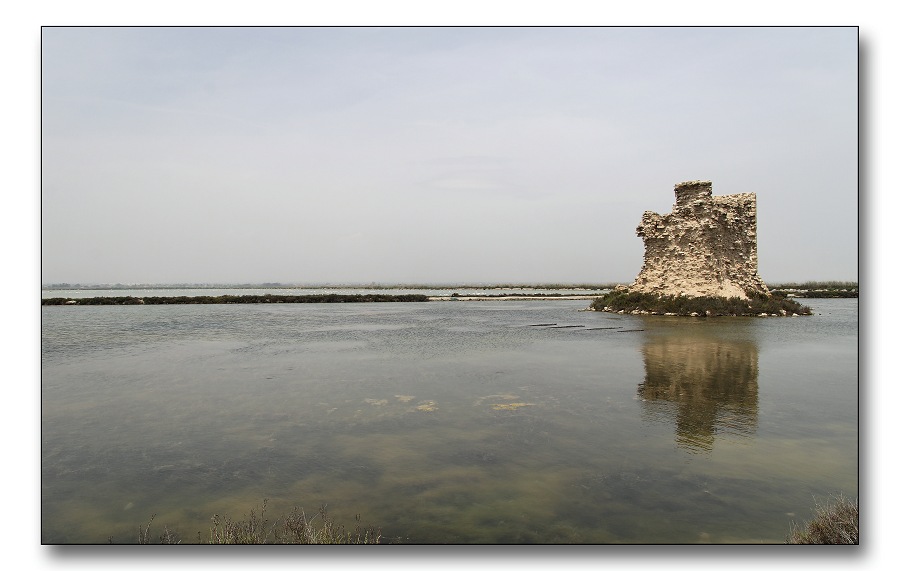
(590, 180), (812, 317)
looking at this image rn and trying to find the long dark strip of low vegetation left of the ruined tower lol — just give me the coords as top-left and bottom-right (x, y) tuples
(41, 293), (428, 305)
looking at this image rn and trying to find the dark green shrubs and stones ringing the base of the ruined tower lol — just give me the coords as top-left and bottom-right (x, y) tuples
(591, 290), (812, 317)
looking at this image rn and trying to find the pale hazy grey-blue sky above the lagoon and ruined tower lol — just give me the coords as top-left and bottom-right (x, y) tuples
(40, 27), (859, 283)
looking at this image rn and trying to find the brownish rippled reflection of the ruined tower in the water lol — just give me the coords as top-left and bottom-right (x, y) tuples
(637, 327), (759, 453)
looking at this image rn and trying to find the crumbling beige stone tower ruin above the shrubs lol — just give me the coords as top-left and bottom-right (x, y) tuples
(628, 180), (769, 299)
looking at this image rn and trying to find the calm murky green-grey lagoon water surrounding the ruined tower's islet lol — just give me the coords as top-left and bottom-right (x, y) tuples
(41, 300), (859, 543)
